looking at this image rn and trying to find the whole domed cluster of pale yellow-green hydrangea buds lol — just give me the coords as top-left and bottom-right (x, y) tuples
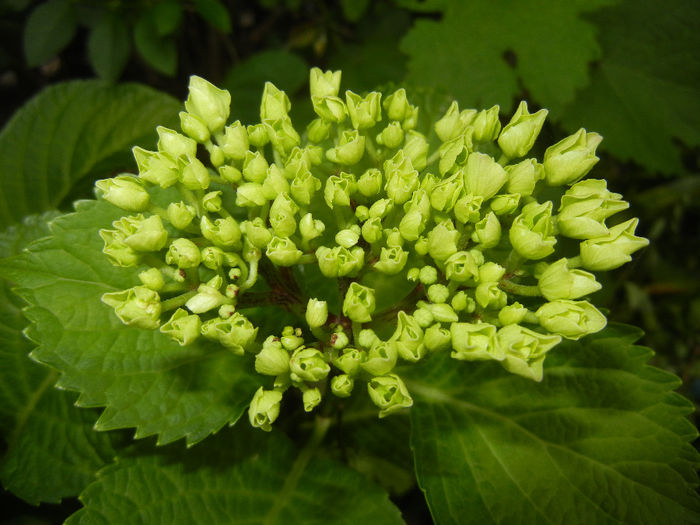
(97, 69), (648, 430)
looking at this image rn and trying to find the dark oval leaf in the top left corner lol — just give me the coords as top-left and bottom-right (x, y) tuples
(24, 0), (77, 67)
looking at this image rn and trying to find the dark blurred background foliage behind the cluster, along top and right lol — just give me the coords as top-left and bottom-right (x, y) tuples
(0, 0), (700, 520)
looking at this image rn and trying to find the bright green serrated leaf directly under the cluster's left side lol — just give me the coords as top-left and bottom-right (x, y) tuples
(0, 201), (261, 444)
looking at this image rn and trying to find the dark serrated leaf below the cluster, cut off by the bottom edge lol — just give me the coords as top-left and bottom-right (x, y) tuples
(67, 426), (403, 525)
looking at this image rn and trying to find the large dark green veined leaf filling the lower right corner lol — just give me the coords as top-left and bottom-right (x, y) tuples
(408, 325), (700, 524)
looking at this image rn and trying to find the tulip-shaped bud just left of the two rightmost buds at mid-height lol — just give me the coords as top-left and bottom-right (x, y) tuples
(508, 201), (557, 259)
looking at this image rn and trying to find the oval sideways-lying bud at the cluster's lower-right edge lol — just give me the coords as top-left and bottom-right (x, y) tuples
(535, 299), (608, 340)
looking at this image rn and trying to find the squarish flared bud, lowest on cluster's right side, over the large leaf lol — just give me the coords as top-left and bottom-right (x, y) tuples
(496, 324), (561, 381)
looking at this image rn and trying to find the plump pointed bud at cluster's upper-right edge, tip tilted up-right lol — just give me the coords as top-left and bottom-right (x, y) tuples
(544, 128), (603, 186)
